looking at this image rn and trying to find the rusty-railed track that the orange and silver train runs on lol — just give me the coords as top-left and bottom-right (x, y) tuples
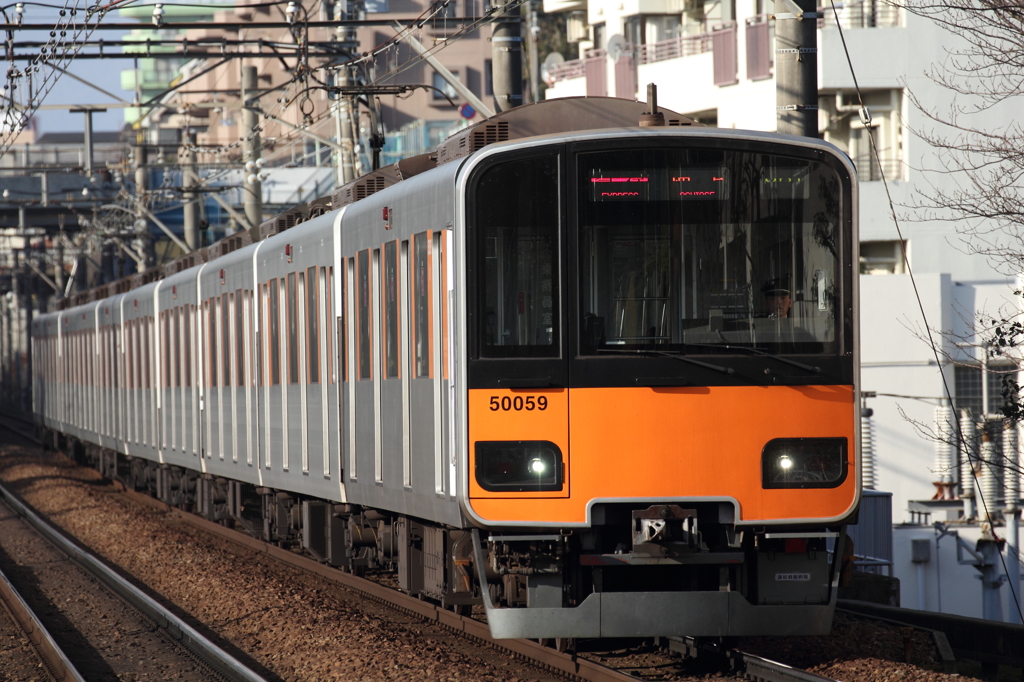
(0, 418), (843, 682)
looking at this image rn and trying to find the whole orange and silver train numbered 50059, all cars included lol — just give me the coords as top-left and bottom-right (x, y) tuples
(33, 98), (860, 638)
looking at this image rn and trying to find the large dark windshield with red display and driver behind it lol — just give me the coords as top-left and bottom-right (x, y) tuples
(577, 148), (843, 355)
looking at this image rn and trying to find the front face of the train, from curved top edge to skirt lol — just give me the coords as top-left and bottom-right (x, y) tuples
(457, 128), (859, 638)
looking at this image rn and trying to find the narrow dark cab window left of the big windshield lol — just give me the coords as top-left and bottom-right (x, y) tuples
(472, 154), (560, 357)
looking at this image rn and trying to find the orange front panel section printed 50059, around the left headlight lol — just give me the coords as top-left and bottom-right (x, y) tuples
(469, 388), (570, 499)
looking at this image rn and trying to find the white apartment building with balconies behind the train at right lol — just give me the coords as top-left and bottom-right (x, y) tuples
(545, 0), (1020, 616)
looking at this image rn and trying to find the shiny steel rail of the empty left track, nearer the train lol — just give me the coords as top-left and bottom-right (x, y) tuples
(0, 475), (266, 682)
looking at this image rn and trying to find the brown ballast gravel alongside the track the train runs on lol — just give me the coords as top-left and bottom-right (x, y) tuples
(0, 436), (991, 682)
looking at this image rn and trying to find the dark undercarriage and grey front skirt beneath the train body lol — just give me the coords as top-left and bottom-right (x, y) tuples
(45, 431), (843, 641)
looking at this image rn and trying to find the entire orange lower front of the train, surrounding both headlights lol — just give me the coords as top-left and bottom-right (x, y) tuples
(469, 386), (857, 523)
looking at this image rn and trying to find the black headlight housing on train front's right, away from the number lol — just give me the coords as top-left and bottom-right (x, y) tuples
(761, 438), (849, 488)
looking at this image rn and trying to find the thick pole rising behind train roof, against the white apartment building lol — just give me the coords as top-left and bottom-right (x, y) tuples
(775, 0), (818, 137)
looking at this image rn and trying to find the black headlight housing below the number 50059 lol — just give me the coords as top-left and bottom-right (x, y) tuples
(475, 440), (563, 493)
